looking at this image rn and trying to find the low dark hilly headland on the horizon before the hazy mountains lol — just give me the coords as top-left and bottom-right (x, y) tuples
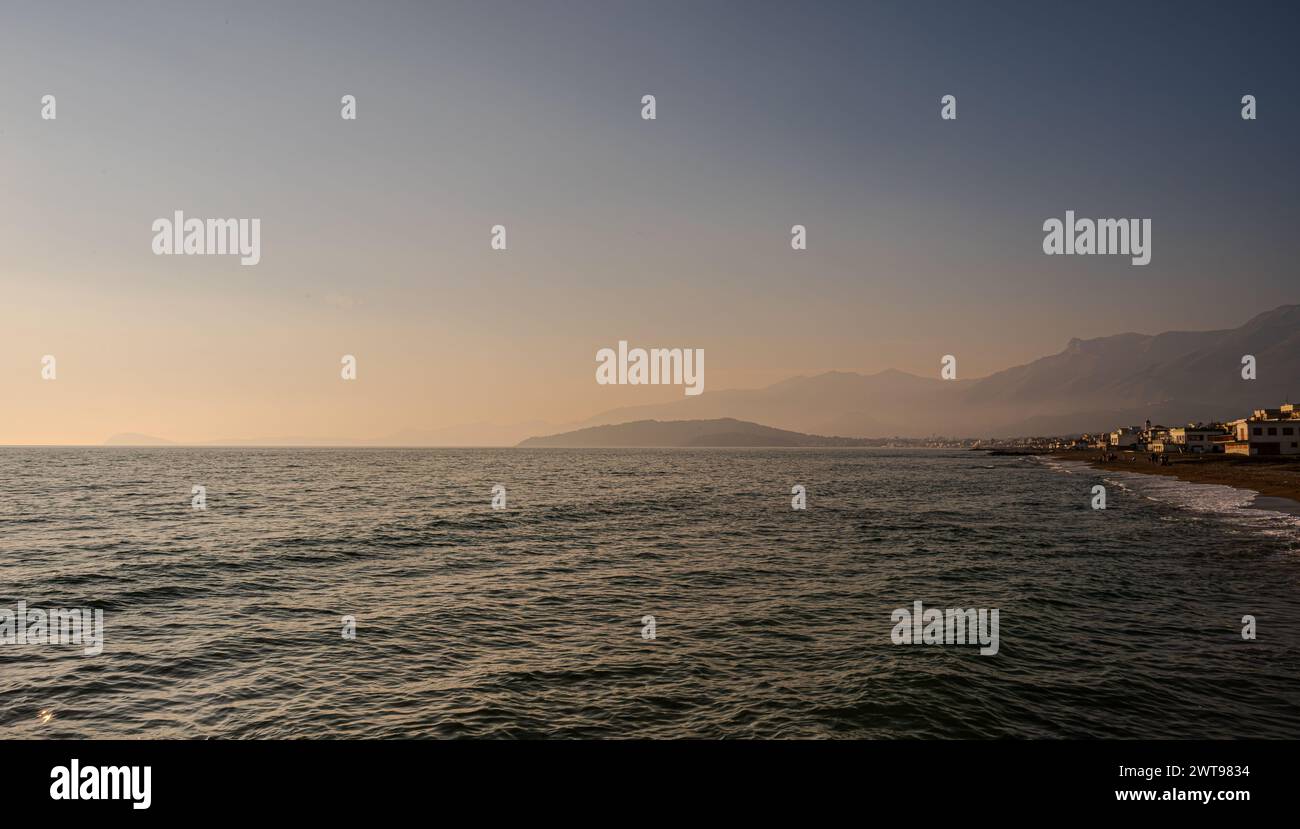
(519, 417), (880, 448)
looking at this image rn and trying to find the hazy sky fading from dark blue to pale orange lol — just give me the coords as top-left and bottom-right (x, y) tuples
(0, 0), (1300, 443)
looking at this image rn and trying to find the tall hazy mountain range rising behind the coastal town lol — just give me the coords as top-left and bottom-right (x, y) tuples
(572, 305), (1300, 438)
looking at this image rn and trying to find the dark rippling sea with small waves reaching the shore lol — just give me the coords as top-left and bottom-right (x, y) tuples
(0, 447), (1300, 739)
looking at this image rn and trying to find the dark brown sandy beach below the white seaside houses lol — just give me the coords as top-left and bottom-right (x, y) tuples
(1053, 450), (1300, 515)
